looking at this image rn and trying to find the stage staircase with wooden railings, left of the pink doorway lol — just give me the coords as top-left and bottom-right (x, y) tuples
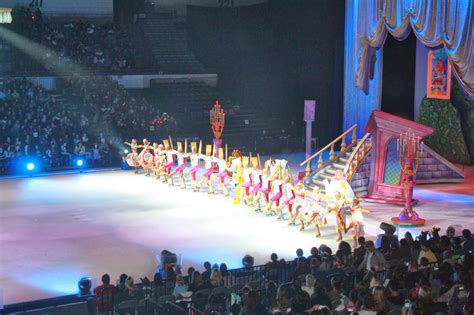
(300, 124), (372, 192)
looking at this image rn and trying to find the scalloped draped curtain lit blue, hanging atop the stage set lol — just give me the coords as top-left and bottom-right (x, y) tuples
(358, 0), (474, 100)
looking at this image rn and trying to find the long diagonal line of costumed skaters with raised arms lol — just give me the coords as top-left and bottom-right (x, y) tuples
(123, 138), (368, 246)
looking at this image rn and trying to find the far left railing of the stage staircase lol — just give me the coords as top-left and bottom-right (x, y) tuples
(300, 124), (357, 177)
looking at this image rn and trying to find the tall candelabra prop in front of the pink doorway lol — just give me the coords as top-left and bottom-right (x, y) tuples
(391, 129), (425, 226)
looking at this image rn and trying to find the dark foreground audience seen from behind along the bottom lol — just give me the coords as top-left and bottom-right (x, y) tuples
(94, 227), (474, 315)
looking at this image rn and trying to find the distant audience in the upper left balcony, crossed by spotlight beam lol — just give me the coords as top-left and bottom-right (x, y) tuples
(11, 8), (155, 72)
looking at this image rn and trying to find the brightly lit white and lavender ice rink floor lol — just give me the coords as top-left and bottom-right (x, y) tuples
(0, 167), (474, 304)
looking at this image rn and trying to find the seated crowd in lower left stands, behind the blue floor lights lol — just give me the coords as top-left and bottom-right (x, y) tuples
(0, 76), (176, 174)
